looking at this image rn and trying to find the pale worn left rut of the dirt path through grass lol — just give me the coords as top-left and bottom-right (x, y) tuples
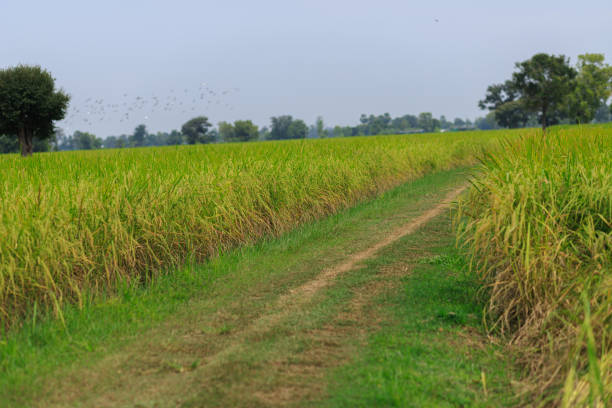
(38, 186), (466, 407)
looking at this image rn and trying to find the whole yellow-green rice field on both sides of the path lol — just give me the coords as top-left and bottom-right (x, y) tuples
(0, 126), (612, 407)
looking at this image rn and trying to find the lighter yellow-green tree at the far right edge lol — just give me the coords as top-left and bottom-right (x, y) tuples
(568, 54), (612, 123)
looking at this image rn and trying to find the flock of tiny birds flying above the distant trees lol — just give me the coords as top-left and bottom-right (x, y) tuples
(62, 82), (240, 134)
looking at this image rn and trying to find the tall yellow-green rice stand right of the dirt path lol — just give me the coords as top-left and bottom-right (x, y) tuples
(457, 126), (612, 407)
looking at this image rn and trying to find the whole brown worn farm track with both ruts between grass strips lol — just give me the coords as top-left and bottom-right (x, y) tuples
(31, 177), (466, 407)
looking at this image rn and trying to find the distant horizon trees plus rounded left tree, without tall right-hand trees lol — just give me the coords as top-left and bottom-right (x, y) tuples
(0, 66), (506, 156)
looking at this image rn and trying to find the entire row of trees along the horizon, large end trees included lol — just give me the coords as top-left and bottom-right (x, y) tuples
(0, 54), (612, 156)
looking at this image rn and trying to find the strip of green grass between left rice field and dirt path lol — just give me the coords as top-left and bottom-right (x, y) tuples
(0, 166), (478, 406)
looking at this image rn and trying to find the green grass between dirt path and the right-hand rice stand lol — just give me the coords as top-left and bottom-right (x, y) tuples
(313, 216), (518, 407)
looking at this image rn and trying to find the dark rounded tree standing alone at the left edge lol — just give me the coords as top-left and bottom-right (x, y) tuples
(0, 65), (70, 157)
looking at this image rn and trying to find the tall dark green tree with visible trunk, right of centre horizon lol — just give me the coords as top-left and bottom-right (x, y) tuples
(512, 53), (577, 131)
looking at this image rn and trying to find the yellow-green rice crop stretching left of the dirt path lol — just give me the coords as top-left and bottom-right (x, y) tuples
(0, 132), (506, 327)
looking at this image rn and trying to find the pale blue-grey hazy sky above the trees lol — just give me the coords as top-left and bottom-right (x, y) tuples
(0, 0), (612, 137)
